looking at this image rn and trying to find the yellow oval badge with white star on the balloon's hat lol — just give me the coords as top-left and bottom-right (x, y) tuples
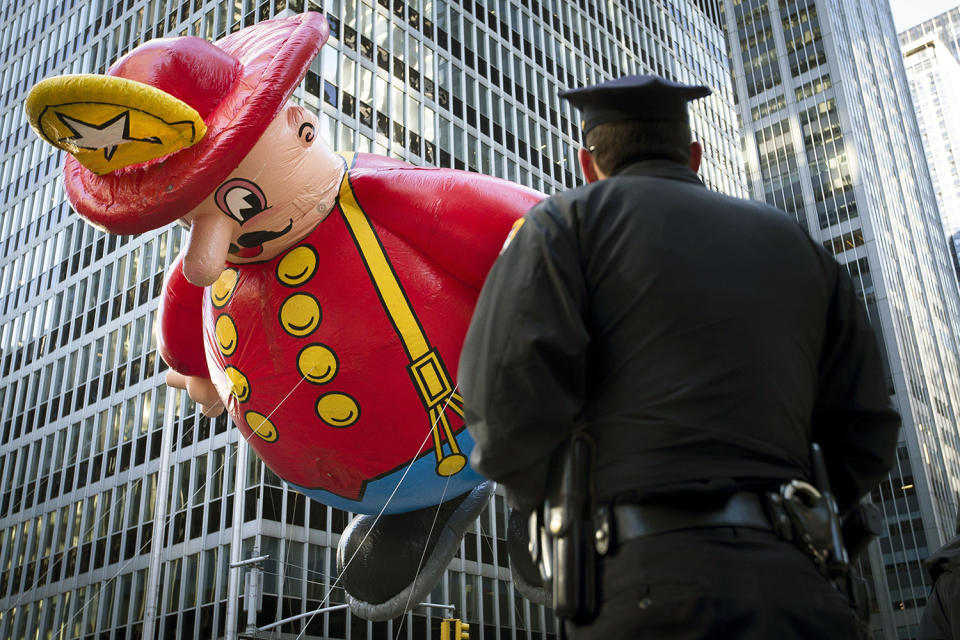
(25, 75), (207, 175)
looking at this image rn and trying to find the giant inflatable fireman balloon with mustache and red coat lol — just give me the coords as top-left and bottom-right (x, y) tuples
(26, 13), (542, 619)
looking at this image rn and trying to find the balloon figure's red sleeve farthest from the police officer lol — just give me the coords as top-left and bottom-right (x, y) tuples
(156, 253), (210, 380)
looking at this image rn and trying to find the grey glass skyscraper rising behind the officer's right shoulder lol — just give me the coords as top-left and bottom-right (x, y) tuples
(724, 0), (960, 638)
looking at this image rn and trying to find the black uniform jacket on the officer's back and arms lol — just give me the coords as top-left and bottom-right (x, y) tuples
(459, 160), (899, 509)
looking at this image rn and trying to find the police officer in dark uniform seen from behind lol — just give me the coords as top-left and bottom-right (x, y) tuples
(459, 76), (900, 638)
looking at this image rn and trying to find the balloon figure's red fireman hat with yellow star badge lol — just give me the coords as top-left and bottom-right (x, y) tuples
(26, 13), (330, 234)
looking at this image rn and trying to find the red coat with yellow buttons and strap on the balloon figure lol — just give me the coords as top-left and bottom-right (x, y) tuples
(159, 154), (542, 510)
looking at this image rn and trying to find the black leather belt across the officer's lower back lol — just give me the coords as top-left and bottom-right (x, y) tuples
(613, 491), (773, 542)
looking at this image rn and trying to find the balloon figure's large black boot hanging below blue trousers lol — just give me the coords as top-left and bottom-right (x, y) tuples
(337, 481), (495, 620)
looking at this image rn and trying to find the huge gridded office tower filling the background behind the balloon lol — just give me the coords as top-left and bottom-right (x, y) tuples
(0, 0), (746, 640)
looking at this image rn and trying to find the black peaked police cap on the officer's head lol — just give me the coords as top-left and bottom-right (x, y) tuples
(560, 75), (712, 137)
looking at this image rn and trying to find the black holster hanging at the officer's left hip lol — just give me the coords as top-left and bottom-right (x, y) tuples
(530, 432), (598, 624)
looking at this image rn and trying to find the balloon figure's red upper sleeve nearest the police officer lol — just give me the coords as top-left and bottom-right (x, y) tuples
(351, 168), (545, 289)
